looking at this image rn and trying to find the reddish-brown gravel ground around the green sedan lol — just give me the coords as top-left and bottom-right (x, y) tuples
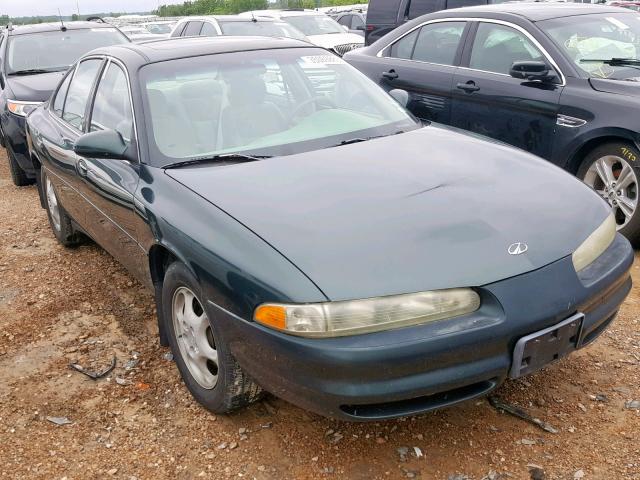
(0, 153), (640, 480)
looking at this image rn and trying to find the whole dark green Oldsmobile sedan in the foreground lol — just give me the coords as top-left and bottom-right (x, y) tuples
(27, 37), (633, 420)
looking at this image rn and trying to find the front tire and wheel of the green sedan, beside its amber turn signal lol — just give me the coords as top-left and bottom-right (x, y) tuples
(162, 262), (262, 413)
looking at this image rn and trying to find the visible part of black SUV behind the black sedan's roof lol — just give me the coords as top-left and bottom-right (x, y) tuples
(364, 0), (504, 45)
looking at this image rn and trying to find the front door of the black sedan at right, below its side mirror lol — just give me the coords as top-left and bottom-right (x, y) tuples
(451, 21), (564, 158)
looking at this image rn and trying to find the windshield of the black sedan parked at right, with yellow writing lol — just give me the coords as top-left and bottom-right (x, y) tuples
(538, 12), (640, 79)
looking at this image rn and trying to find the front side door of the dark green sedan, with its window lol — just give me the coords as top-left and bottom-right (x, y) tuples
(78, 60), (146, 278)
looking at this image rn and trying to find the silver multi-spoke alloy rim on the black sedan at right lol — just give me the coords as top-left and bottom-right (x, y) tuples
(584, 155), (638, 230)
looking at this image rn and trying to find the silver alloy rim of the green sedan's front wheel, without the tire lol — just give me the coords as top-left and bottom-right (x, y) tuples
(172, 287), (218, 390)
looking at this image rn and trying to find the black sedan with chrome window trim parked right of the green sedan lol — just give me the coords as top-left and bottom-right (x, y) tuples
(345, 3), (640, 241)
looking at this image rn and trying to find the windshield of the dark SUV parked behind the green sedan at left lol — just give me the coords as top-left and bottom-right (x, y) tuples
(6, 28), (129, 75)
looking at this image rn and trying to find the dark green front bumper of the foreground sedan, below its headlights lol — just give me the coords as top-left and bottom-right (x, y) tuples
(208, 235), (633, 420)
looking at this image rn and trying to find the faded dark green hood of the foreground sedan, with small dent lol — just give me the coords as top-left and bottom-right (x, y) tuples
(166, 126), (610, 300)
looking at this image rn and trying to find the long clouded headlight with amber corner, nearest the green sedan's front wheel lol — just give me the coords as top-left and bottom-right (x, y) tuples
(253, 288), (480, 337)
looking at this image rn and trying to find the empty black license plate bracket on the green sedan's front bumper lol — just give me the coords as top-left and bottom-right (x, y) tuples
(509, 313), (584, 378)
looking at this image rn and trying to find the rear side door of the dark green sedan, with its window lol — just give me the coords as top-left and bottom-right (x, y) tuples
(42, 57), (104, 229)
